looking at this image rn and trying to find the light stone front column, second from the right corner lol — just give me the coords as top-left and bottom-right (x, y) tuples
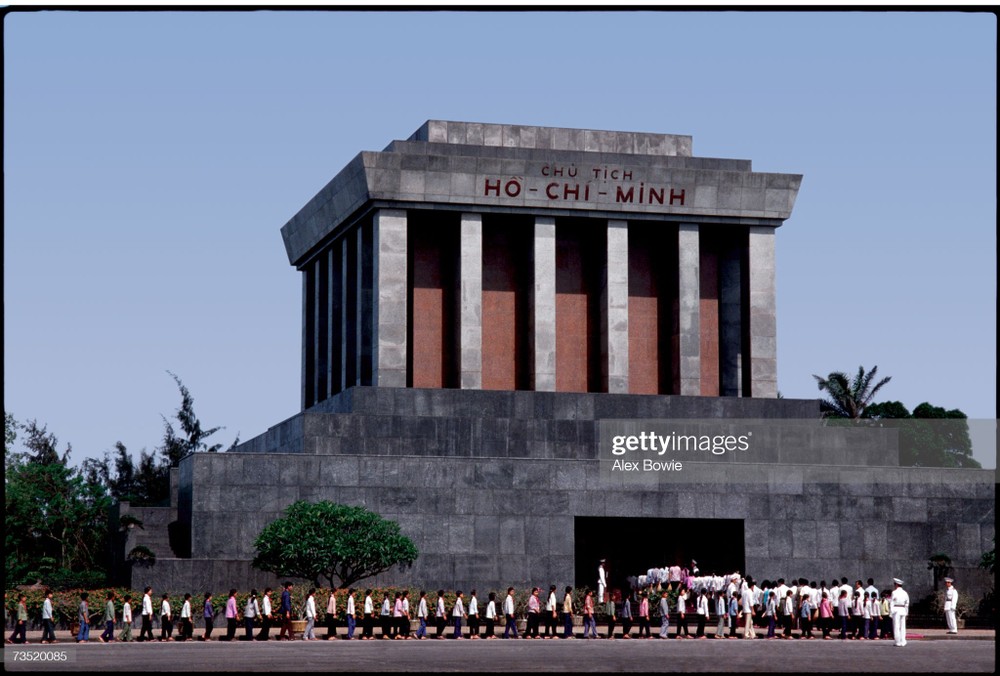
(677, 223), (701, 396)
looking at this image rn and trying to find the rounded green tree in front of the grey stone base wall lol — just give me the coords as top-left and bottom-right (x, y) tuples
(253, 500), (418, 586)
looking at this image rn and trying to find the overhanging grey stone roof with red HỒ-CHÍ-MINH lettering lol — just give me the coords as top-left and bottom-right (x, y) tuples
(281, 120), (802, 266)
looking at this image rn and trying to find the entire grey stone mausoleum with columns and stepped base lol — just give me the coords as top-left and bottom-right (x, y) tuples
(129, 120), (995, 594)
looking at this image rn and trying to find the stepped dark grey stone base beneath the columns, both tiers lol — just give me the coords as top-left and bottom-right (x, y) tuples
(133, 388), (995, 594)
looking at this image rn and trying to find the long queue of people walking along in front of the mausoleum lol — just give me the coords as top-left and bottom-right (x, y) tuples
(1, 576), (916, 645)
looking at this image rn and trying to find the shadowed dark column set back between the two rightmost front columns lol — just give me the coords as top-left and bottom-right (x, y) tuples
(719, 241), (743, 397)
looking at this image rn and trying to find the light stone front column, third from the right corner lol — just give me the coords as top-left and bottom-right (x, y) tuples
(601, 221), (628, 394)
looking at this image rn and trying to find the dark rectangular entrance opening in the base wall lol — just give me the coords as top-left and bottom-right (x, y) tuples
(574, 516), (746, 590)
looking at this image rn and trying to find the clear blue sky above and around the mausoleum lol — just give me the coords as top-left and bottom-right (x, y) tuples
(4, 11), (997, 461)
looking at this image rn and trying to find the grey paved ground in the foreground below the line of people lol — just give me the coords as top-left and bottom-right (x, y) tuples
(3, 629), (996, 672)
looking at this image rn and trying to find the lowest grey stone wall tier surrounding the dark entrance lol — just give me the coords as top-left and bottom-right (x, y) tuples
(178, 453), (995, 594)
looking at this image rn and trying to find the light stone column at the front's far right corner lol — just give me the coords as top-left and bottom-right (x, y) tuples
(748, 226), (778, 398)
